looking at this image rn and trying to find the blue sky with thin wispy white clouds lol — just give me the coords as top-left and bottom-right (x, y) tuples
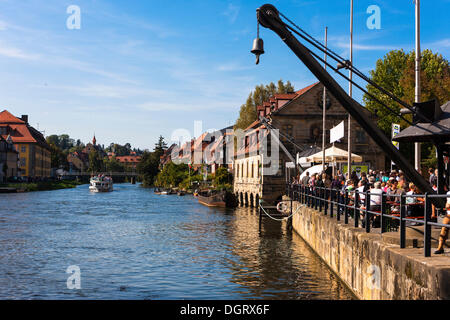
(0, 0), (450, 149)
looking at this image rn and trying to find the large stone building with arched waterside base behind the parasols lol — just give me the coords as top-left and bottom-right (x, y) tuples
(234, 82), (385, 205)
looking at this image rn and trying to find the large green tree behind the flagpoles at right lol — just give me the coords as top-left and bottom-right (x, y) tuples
(363, 50), (450, 165)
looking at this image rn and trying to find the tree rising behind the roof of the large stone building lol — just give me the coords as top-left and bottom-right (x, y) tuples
(234, 80), (294, 129)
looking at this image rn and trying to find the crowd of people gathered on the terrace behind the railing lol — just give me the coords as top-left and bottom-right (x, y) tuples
(292, 168), (450, 254)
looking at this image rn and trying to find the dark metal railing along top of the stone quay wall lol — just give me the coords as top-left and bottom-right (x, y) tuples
(287, 185), (450, 257)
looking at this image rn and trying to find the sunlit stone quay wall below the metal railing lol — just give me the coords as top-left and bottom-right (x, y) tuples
(286, 198), (450, 300)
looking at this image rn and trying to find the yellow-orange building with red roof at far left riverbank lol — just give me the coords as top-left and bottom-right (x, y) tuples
(0, 110), (51, 178)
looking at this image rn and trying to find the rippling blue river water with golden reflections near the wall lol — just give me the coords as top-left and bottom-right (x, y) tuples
(0, 184), (353, 299)
